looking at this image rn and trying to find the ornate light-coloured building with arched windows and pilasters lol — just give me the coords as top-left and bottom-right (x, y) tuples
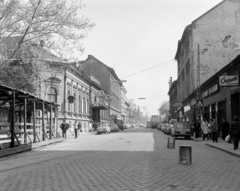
(38, 62), (110, 132)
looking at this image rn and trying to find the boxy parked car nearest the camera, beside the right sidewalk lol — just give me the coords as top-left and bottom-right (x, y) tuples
(171, 122), (191, 139)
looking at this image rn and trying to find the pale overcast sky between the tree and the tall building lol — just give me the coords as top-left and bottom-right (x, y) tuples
(80, 0), (221, 115)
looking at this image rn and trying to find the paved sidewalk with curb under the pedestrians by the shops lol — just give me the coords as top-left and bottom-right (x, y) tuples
(192, 137), (240, 158)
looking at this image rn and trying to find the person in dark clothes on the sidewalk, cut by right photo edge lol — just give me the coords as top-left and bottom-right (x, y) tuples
(229, 116), (240, 150)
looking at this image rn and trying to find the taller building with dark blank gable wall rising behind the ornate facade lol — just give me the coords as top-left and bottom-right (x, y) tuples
(79, 55), (122, 125)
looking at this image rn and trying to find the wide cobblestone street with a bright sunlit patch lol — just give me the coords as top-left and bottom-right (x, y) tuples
(0, 128), (240, 191)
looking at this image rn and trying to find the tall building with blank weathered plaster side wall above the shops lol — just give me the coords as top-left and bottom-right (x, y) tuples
(170, 0), (240, 120)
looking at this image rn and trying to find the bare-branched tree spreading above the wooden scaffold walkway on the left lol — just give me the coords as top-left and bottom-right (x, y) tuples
(0, 0), (95, 91)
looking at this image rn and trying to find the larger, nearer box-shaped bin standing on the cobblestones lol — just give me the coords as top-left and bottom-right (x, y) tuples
(179, 145), (192, 164)
